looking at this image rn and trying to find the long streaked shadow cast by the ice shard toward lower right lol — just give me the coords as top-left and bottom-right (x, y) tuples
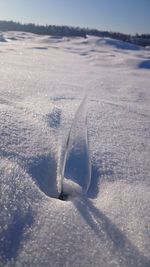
(72, 197), (150, 267)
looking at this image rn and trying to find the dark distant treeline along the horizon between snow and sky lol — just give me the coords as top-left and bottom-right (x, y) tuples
(0, 21), (150, 46)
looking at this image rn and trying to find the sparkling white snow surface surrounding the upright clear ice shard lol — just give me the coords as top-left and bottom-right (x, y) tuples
(0, 32), (150, 267)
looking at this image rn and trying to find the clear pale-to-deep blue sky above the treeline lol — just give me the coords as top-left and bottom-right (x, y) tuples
(0, 0), (150, 33)
